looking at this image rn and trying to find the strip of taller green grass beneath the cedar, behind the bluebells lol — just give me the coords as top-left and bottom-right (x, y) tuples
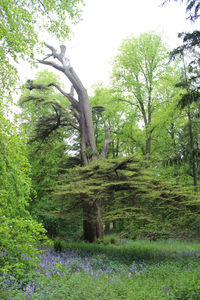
(63, 236), (200, 263)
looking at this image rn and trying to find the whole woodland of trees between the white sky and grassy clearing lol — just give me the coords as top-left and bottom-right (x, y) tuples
(0, 0), (200, 284)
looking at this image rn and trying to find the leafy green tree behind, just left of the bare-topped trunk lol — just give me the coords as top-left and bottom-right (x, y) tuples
(19, 71), (80, 236)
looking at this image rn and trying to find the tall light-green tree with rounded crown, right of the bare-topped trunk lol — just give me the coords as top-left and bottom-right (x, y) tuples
(113, 33), (170, 159)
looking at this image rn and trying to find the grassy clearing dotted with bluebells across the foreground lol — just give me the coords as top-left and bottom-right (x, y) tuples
(0, 237), (200, 300)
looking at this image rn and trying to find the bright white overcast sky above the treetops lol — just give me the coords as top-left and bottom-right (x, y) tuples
(20, 0), (198, 92)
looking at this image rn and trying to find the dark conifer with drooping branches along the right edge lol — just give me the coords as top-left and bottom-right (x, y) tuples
(163, 0), (200, 192)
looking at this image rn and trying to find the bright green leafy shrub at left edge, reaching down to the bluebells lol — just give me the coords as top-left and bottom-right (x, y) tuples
(0, 105), (45, 276)
